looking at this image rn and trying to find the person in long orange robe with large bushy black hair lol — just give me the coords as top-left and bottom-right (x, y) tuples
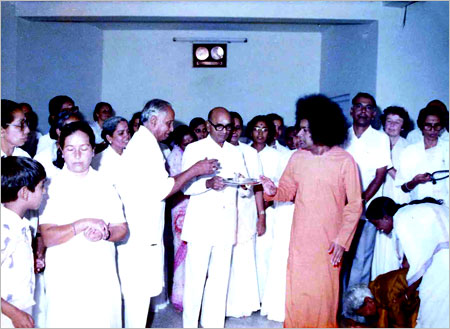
(261, 95), (362, 328)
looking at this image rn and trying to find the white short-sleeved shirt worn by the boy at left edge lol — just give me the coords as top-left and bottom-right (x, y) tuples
(1, 205), (35, 310)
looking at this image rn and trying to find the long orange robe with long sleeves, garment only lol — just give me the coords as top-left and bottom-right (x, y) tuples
(265, 146), (362, 328)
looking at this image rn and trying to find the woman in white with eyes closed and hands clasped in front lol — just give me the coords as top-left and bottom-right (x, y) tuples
(39, 121), (128, 328)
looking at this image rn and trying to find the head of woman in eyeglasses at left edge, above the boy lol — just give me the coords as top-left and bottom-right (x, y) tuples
(1, 99), (30, 158)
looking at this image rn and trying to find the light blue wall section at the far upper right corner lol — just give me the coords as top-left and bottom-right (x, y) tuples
(377, 1), (449, 121)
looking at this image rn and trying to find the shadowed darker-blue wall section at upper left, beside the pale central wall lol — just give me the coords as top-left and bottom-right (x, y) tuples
(15, 19), (102, 132)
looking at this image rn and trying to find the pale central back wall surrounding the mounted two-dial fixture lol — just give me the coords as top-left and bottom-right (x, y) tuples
(102, 31), (321, 125)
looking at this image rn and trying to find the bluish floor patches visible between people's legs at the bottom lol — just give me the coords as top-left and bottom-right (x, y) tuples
(147, 304), (283, 328)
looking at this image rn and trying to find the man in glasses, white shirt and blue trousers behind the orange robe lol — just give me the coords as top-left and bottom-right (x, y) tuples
(343, 92), (392, 293)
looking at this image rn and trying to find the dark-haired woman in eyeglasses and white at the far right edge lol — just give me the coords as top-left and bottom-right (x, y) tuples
(395, 106), (449, 206)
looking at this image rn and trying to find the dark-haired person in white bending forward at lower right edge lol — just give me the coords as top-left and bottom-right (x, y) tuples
(366, 197), (449, 328)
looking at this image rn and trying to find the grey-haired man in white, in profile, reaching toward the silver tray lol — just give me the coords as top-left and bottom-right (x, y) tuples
(116, 99), (218, 328)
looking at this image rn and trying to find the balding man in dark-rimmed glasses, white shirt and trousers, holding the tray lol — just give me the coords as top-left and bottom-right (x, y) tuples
(181, 107), (249, 328)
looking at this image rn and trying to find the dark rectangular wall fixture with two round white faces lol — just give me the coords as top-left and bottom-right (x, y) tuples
(192, 43), (227, 67)
